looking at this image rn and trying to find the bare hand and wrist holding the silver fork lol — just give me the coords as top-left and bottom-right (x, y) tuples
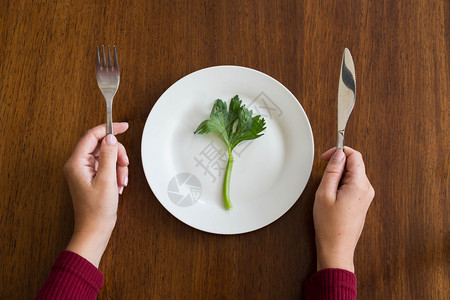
(64, 123), (129, 267)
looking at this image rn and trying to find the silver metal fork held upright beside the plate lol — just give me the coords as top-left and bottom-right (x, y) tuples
(96, 45), (120, 135)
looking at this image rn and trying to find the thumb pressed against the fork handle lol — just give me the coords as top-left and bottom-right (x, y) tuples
(95, 134), (118, 183)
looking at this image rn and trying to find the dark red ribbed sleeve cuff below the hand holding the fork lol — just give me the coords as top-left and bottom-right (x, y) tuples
(35, 250), (103, 299)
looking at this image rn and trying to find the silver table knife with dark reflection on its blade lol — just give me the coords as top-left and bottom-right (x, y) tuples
(336, 48), (356, 150)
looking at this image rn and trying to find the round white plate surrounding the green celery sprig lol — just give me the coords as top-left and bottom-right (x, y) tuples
(142, 66), (314, 234)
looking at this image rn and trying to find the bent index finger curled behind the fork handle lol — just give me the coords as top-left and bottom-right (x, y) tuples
(73, 122), (128, 156)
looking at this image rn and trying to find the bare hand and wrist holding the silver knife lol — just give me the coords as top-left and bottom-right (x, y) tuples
(313, 147), (375, 272)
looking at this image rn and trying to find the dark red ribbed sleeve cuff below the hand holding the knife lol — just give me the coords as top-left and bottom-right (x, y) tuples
(305, 269), (356, 300)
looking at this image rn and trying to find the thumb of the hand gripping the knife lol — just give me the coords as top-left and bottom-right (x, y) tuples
(318, 149), (346, 201)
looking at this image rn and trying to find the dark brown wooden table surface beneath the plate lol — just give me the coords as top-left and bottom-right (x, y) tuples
(0, 0), (450, 299)
